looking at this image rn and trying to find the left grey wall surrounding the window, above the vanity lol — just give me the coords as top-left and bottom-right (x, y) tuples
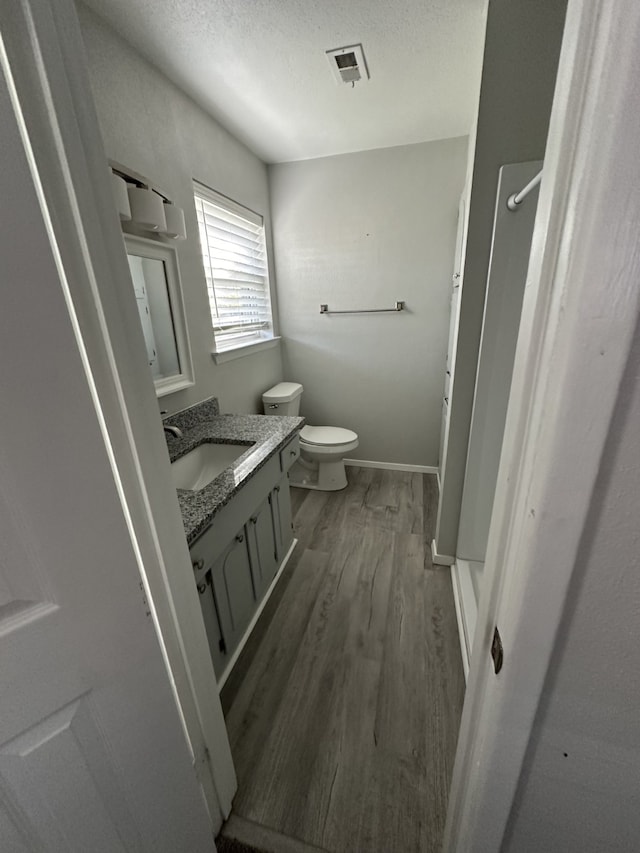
(78, 3), (282, 412)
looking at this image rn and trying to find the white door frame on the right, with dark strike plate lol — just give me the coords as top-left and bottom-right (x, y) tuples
(443, 0), (640, 853)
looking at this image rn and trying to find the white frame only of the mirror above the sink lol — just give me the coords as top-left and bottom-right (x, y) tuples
(122, 234), (195, 397)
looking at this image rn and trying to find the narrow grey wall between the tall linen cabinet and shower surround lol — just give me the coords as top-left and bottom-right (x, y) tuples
(436, 0), (566, 556)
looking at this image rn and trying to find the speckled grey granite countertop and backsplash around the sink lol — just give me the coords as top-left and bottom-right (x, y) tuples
(165, 398), (304, 545)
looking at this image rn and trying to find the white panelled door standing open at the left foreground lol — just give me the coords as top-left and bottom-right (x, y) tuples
(0, 61), (215, 853)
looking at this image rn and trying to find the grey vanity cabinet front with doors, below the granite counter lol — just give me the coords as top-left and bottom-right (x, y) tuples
(191, 435), (299, 680)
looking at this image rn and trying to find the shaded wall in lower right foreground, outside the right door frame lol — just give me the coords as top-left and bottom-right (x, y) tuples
(504, 322), (640, 853)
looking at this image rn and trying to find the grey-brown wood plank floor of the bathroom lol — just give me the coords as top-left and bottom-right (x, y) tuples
(222, 468), (464, 853)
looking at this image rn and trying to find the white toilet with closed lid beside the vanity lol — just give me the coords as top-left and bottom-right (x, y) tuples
(262, 382), (358, 492)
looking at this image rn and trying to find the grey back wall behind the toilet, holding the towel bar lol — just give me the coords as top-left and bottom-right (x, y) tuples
(269, 137), (467, 465)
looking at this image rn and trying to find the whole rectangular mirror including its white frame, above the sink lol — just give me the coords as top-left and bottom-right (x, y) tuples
(124, 234), (194, 397)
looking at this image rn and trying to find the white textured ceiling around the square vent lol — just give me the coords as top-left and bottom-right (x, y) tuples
(85, 0), (487, 163)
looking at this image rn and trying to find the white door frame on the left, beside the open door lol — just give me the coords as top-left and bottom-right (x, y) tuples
(0, 0), (237, 834)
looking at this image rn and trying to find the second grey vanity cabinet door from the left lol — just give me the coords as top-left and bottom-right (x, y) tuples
(211, 529), (256, 660)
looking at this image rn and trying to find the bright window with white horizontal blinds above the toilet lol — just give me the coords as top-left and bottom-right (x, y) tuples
(194, 184), (273, 353)
